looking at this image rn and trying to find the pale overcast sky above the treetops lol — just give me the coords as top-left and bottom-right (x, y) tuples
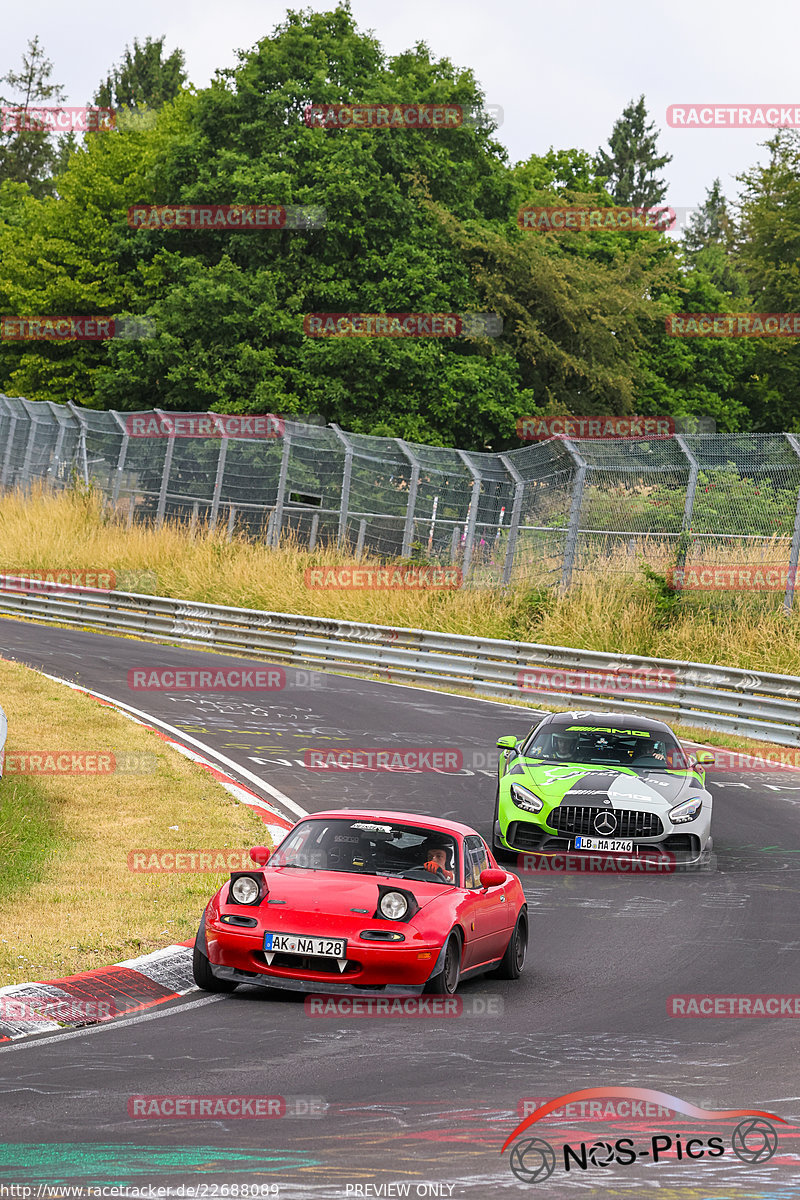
(0, 0), (800, 208)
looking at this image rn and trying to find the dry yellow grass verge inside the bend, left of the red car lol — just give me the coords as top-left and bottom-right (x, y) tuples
(0, 660), (269, 985)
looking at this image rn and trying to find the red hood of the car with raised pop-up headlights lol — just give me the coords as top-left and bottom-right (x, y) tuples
(244, 866), (452, 917)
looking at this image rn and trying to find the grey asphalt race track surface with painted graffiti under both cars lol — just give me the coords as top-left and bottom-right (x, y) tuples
(0, 620), (800, 1200)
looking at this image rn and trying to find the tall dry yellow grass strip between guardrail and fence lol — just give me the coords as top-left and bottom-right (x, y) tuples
(0, 490), (800, 674)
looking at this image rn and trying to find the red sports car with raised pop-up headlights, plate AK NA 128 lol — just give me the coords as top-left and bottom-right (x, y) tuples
(193, 809), (528, 995)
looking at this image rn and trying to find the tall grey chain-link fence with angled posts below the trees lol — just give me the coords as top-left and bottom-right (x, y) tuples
(0, 396), (800, 608)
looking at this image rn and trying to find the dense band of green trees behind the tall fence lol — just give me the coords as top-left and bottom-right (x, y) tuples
(0, 4), (800, 441)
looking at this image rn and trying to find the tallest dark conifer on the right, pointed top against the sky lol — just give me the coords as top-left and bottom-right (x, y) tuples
(595, 96), (672, 208)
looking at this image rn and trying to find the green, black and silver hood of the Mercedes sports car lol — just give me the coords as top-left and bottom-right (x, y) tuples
(510, 760), (705, 812)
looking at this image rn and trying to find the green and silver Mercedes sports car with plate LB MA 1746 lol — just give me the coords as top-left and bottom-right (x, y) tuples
(493, 713), (714, 864)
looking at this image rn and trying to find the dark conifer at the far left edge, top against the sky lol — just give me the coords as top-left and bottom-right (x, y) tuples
(0, 37), (76, 196)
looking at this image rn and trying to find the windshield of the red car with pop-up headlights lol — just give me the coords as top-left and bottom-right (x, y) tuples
(266, 817), (458, 884)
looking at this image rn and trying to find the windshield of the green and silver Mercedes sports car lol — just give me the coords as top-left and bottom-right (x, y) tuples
(523, 725), (688, 770)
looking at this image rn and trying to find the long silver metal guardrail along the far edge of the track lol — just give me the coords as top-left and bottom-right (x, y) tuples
(0, 584), (800, 745)
